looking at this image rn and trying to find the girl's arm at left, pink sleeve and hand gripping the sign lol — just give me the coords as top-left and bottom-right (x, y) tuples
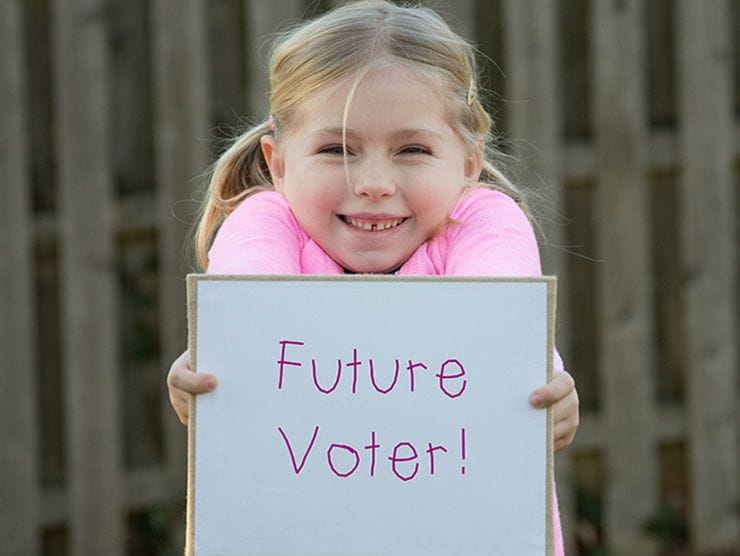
(167, 191), (304, 424)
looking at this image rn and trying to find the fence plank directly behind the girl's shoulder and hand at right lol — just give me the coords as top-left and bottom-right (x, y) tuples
(503, 0), (575, 553)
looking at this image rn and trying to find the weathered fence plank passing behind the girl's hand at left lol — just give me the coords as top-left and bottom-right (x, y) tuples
(151, 0), (210, 520)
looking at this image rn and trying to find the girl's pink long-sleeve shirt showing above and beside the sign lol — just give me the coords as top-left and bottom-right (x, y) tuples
(208, 187), (564, 556)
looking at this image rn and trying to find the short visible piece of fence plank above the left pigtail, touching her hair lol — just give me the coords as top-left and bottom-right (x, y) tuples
(244, 0), (305, 121)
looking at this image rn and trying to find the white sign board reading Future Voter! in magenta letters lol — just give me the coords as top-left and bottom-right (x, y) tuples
(187, 275), (555, 556)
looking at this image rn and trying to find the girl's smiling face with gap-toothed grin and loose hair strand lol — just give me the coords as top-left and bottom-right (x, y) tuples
(262, 66), (481, 273)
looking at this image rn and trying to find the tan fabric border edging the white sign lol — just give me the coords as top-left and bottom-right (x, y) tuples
(185, 274), (557, 556)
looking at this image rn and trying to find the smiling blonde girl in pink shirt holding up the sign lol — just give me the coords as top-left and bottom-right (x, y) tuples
(168, 0), (578, 554)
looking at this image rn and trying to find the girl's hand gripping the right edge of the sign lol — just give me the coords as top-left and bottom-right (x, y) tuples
(529, 371), (579, 452)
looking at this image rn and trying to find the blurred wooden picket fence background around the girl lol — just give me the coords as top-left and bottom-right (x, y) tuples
(0, 0), (740, 556)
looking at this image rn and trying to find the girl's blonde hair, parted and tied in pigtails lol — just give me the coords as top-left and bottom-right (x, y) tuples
(195, 0), (530, 268)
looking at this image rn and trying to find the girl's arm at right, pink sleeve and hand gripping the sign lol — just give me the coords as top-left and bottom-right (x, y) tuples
(445, 188), (579, 450)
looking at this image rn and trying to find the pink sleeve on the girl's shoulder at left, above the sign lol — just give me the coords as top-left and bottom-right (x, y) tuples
(207, 191), (303, 274)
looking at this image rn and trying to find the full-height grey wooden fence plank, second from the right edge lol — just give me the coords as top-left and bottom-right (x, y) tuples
(592, 0), (658, 555)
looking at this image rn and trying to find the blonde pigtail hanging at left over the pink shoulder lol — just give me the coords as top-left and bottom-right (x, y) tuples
(195, 122), (272, 270)
